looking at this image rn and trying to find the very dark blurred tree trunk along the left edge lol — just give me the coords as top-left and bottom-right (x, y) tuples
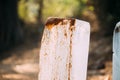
(0, 0), (20, 51)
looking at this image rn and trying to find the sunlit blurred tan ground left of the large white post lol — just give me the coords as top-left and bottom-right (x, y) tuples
(0, 42), (40, 80)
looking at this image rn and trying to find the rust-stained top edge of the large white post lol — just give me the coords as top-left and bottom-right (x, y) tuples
(45, 17), (90, 30)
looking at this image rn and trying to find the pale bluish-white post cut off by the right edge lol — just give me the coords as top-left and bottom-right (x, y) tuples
(113, 22), (120, 80)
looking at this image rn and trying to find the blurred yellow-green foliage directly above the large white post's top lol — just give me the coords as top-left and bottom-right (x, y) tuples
(43, 0), (79, 20)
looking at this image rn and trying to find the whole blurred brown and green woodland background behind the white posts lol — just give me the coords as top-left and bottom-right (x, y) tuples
(0, 0), (120, 80)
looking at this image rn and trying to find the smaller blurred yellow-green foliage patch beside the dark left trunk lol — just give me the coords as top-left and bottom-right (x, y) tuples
(18, 0), (39, 23)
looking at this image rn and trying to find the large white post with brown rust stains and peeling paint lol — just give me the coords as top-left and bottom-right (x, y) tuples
(39, 18), (90, 80)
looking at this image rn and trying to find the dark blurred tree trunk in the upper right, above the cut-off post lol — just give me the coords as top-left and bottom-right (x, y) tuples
(89, 0), (120, 36)
